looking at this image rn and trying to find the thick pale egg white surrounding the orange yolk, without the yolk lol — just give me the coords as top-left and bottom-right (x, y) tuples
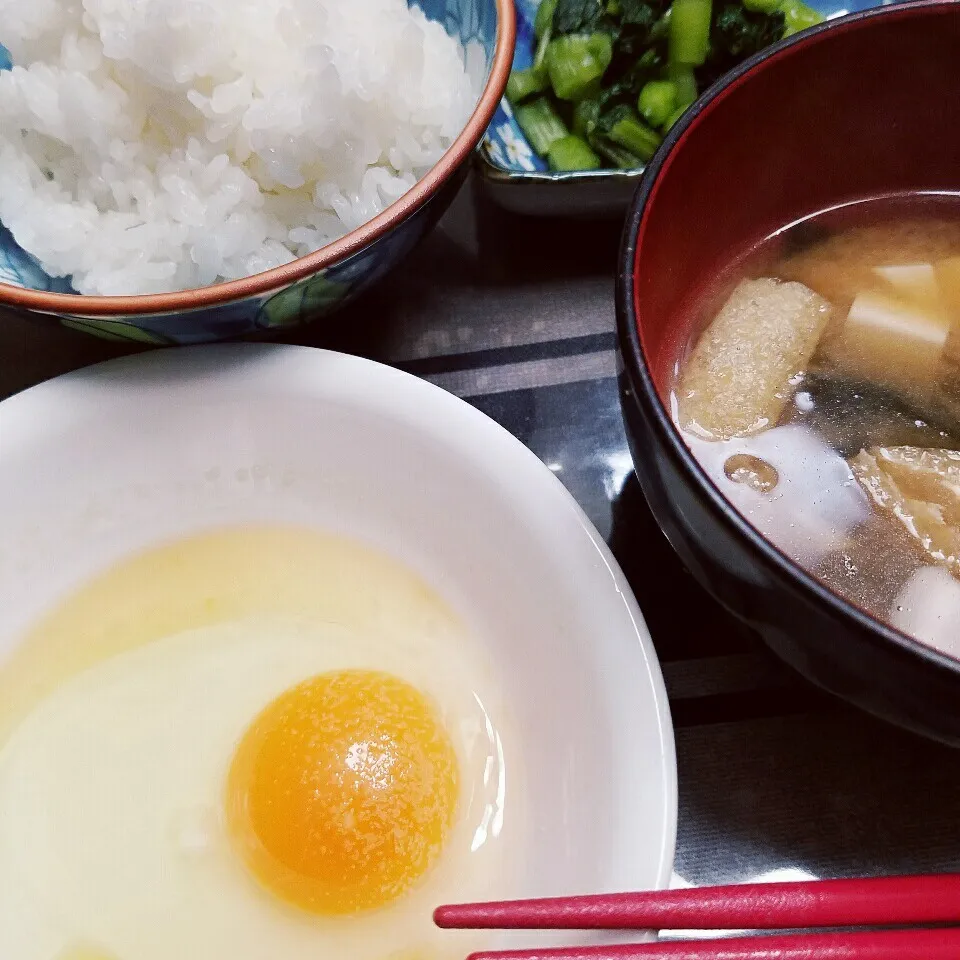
(0, 608), (510, 960)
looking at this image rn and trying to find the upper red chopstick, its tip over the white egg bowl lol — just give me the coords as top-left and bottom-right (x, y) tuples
(434, 874), (960, 928)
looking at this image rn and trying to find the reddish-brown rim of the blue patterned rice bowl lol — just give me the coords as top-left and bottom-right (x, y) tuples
(0, 0), (517, 317)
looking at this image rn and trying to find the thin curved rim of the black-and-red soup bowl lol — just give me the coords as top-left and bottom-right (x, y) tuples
(616, 0), (960, 675)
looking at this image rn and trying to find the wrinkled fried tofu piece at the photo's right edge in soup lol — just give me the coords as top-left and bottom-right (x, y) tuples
(850, 447), (960, 577)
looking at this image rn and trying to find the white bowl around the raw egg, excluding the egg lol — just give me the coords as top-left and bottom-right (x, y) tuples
(0, 344), (677, 943)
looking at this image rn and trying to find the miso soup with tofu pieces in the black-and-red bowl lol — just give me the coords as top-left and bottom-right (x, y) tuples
(671, 195), (960, 657)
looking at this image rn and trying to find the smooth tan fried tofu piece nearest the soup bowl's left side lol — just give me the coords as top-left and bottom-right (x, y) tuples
(677, 279), (832, 440)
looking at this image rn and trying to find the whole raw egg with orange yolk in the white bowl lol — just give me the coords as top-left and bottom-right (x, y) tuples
(0, 528), (522, 960)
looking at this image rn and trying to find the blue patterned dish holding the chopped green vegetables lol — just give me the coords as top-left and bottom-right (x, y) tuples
(477, 0), (886, 217)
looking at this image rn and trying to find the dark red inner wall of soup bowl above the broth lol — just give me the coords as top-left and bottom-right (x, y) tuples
(628, 2), (960, 399)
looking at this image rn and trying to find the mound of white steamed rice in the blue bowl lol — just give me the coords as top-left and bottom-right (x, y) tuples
(0, 0), (484, 295)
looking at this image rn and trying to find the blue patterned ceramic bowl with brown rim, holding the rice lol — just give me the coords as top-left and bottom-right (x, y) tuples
(0, 0), (515, 345)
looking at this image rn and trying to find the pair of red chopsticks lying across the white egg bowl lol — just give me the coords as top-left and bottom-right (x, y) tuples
(434, 874), (960, 960)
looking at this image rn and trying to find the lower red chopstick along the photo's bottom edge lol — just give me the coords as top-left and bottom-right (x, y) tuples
(467, 930), (960, 960)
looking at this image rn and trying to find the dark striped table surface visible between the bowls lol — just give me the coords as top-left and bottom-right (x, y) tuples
(0, 174), (960, 900)
